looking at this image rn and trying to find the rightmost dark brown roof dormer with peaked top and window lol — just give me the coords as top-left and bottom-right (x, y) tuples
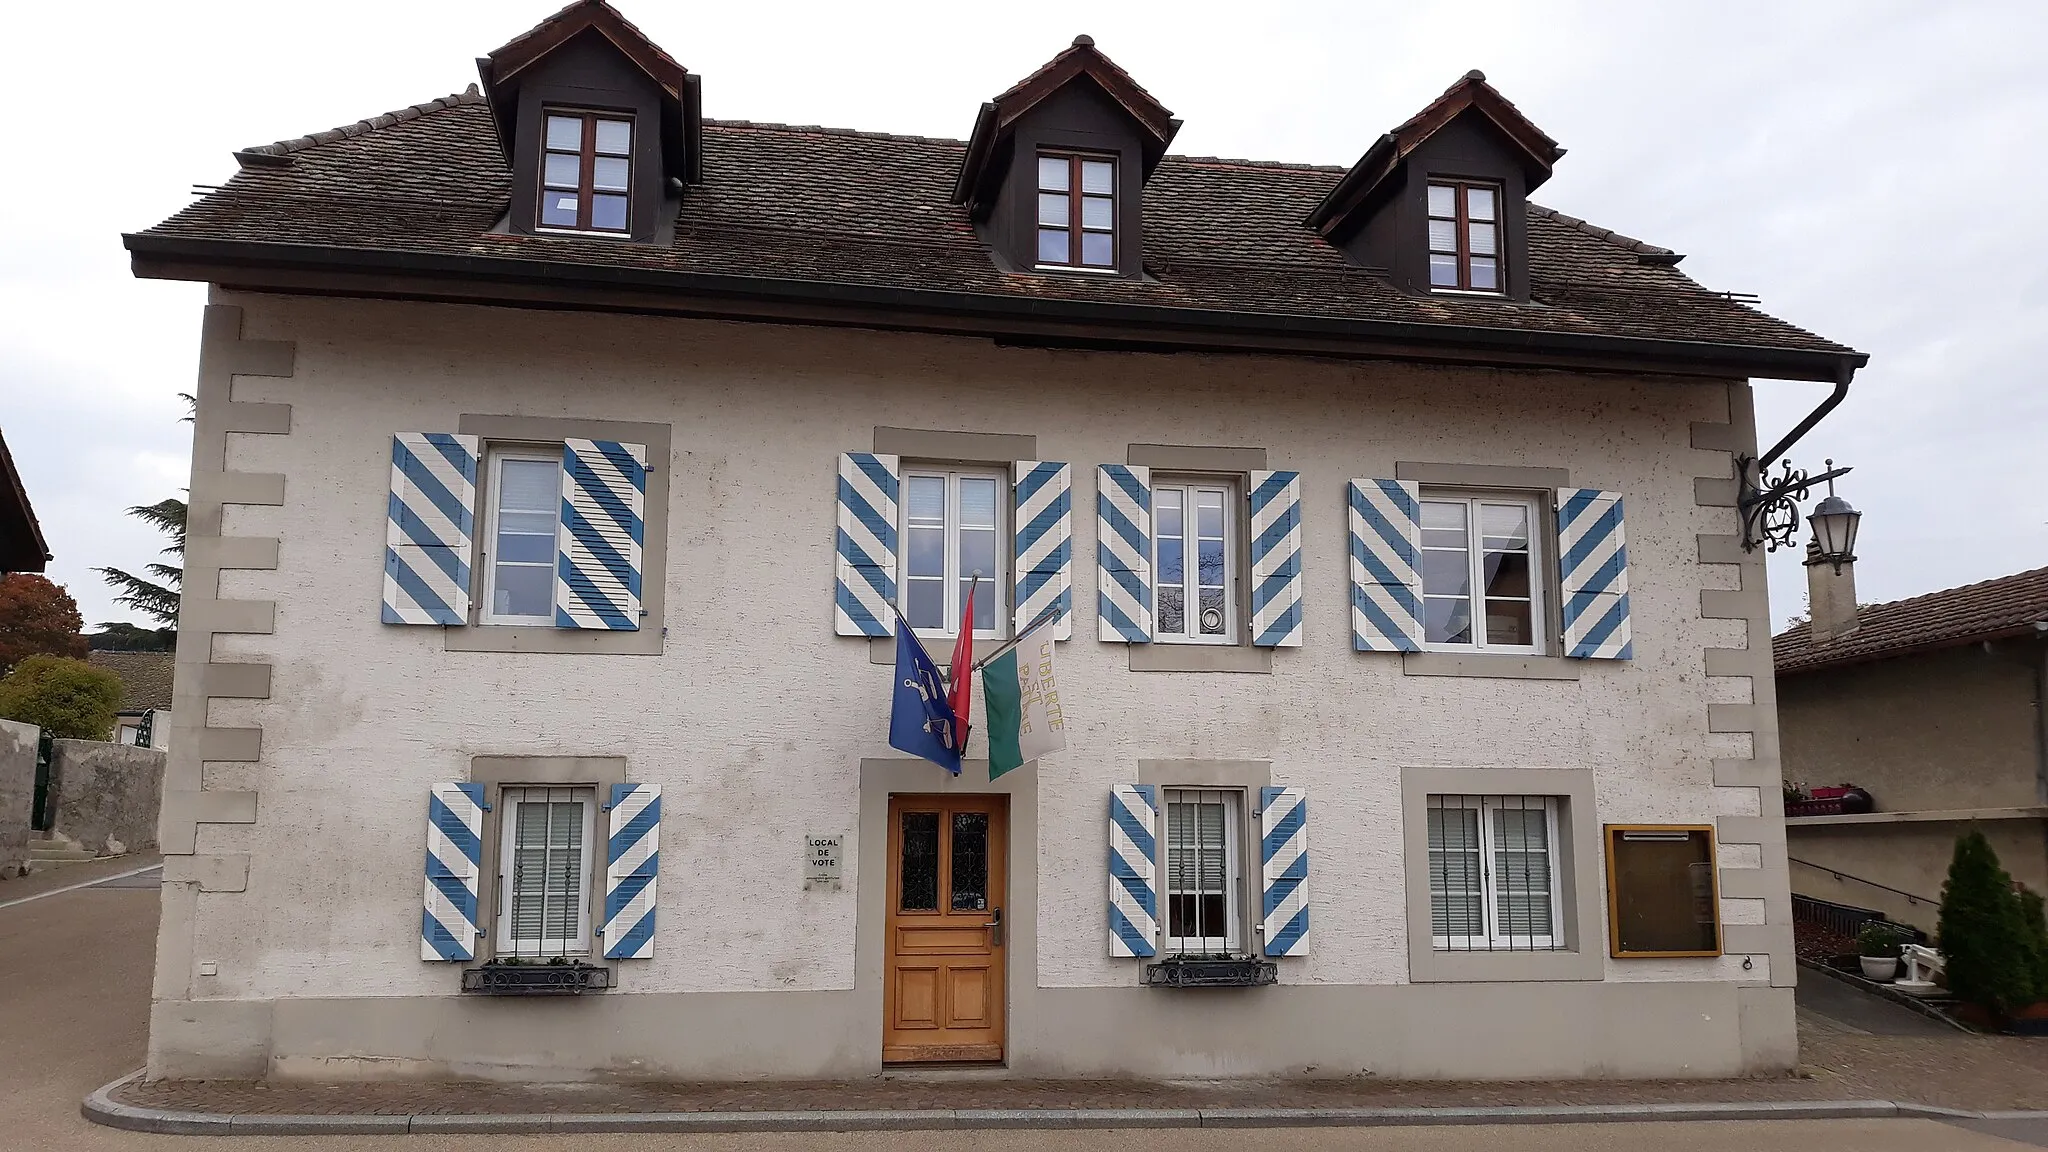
(1307, 70), (1565, 301)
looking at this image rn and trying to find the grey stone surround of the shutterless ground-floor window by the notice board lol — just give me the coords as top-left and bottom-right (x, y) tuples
(1401, 769), (1608, 984)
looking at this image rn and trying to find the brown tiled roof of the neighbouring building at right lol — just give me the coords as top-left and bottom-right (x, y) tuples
(1772, 568), (2048, 676)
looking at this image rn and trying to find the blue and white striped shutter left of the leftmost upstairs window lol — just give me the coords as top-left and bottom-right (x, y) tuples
(381, 433), (477, 625)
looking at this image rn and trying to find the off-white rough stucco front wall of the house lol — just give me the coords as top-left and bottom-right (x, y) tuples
(152, 293), (1792, 1076)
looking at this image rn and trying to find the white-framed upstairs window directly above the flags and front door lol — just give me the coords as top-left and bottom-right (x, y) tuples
(897, 467), (1010, 640)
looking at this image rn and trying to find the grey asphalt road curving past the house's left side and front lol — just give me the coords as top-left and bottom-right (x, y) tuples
(0, 859), (2025, 1152)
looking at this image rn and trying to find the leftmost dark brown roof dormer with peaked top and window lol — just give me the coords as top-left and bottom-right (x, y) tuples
(477, 0), (702, 240)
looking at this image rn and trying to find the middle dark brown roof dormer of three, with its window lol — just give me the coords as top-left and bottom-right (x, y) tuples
(952, 37), (1180, 277)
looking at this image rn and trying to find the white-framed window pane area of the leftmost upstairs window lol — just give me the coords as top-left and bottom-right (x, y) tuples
(481, 449), (561, 625)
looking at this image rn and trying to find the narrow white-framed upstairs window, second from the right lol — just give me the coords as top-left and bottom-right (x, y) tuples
(1153, 478), (1237, 644)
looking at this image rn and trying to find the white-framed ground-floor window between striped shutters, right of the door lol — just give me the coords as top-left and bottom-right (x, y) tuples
(1161, 787), (1243, 955)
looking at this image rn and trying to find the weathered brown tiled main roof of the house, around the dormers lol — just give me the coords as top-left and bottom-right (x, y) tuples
(145, 90), (1853, 355)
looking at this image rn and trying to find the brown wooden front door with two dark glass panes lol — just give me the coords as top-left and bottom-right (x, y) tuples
(883, 795), (1010, 1064)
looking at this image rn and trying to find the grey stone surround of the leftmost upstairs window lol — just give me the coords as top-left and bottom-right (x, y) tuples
(440, 412), (672, 656)
